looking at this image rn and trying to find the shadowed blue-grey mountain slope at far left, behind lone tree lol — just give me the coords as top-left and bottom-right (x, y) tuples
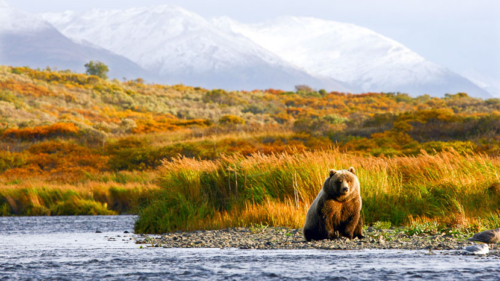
(0, 1), (155, 79)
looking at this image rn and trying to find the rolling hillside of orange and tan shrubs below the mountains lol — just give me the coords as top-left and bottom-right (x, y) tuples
(0, 66), (500, 165)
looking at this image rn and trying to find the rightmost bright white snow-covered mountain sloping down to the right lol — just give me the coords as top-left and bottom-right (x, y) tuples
(213, 17), (490, 98)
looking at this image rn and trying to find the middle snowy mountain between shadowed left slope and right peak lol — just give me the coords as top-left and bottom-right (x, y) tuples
(44, 5), (350, 91)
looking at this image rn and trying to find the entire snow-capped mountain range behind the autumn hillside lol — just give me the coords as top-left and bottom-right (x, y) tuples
(0, 0), (491, 98)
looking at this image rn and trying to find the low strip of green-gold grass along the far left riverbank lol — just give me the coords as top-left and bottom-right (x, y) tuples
(0, 180), (157, 216)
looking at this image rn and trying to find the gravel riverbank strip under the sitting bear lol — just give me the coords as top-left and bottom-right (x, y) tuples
(136, 227), (500, 254)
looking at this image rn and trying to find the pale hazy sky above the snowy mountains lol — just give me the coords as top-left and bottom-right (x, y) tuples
(7, 0), (500, 89)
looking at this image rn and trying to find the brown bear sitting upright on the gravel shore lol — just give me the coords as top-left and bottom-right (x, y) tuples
(304, 167), (363, 241)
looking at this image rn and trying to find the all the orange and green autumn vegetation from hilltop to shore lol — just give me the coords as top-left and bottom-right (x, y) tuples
(0, 66), (500, 233)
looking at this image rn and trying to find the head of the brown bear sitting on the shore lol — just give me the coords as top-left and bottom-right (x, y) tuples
(323, 167), (359, 201)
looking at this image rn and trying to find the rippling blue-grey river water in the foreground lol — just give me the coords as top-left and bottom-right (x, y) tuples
(0, 216), (500, 280)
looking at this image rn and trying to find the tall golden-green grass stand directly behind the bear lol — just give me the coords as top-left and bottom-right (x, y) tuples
(135, 149), (500, 233)
